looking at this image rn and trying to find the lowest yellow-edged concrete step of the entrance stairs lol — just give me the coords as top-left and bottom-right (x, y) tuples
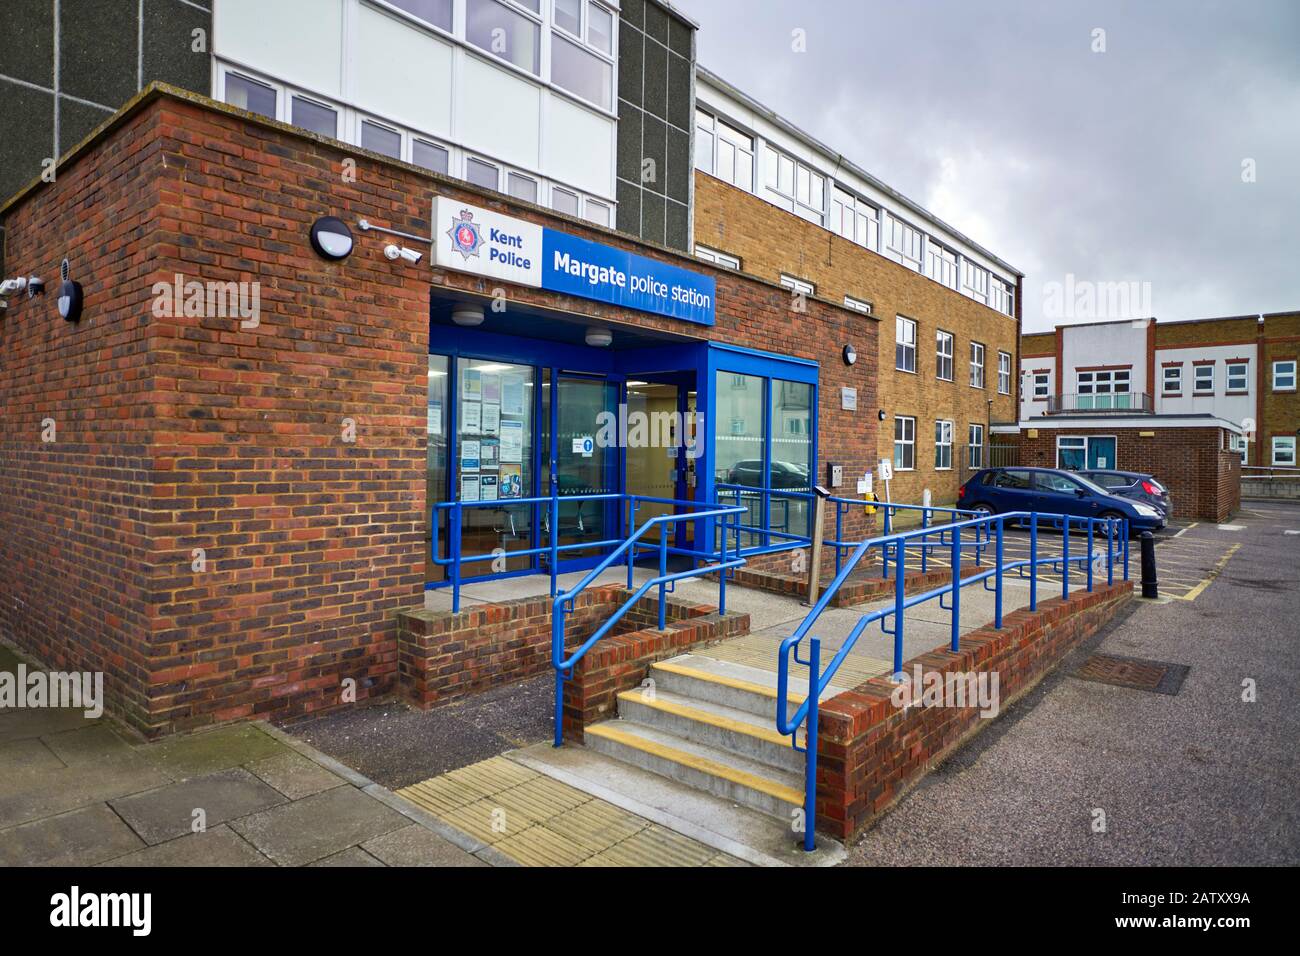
(584, 719), (803, 821)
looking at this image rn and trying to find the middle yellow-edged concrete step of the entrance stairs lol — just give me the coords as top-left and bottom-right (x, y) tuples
(619, 684), (805, 774)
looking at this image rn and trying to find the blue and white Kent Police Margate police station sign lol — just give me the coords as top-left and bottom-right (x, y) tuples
(433, 196), (716, 325)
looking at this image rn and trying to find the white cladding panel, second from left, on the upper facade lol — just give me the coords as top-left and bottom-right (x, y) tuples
(352, 4), (452, 139)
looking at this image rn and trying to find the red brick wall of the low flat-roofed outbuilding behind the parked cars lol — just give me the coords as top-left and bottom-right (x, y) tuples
(1008, 429), (1242, 522)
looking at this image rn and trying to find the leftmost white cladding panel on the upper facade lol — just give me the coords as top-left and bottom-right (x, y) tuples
(212, 0), (343, 99)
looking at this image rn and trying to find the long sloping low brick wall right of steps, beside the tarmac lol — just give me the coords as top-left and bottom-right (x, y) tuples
(816, 581), (1132, 840)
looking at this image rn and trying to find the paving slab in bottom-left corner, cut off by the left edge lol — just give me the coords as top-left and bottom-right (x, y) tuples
(0, 804), (144, 866)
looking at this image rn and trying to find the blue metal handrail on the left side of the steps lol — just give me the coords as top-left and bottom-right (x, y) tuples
(551, 498), (745, 747)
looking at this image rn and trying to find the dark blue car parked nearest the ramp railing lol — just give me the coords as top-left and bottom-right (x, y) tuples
(957, 468), (1165, 533)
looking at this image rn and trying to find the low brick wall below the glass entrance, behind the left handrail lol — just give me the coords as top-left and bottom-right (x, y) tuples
(398, 584), (749, 709)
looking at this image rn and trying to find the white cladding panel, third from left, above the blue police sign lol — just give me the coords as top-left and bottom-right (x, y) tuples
(456, 56), (540, 172)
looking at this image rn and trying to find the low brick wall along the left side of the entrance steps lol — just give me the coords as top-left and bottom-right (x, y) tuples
(564, 601), (749, 743)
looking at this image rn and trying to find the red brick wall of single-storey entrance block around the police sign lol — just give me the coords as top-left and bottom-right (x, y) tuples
(0, 91), (878, 735)
